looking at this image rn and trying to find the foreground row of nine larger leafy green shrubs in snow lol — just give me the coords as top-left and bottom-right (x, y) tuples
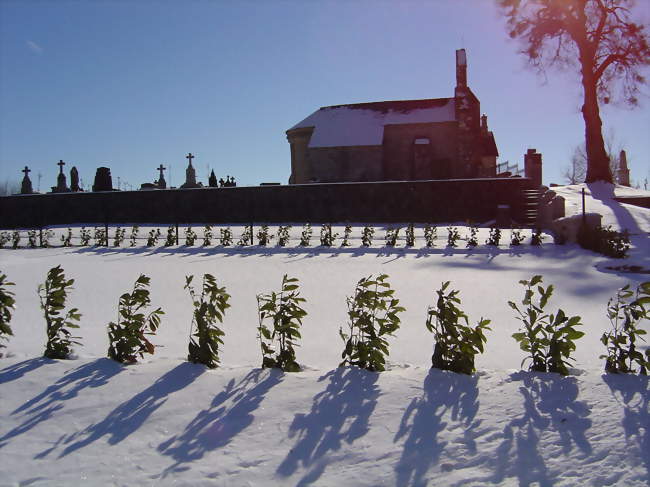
(0, 266), (650, 375)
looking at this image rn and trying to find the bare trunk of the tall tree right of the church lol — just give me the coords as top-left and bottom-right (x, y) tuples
(582, 67), (612, 183)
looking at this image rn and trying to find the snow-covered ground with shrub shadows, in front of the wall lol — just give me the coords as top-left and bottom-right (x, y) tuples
(0, 187), (650, 486)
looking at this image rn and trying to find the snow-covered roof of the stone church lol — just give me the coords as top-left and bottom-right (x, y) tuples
(289, 98), (456, 147)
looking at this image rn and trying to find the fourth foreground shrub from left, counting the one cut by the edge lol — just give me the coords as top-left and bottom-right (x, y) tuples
(183, 274), (230, 369)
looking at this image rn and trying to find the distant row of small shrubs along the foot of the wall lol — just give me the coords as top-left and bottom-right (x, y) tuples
(0, 223), (543, 249)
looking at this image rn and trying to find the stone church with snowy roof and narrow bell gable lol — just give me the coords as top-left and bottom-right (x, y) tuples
(286, 49), (499, 184)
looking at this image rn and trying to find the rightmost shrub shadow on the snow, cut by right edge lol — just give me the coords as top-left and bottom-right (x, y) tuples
(603, 374), (650, 484)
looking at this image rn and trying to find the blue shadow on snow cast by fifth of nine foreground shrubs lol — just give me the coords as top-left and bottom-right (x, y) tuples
(158, 369), (284, 476)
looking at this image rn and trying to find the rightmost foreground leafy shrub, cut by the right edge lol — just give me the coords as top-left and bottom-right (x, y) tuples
(600, 281), (650, 375)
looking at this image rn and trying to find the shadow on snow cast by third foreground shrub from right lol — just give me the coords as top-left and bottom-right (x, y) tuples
(393, 369), (481, 486)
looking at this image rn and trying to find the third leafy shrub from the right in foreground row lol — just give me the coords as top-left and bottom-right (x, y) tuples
(426, 281), (490, 374)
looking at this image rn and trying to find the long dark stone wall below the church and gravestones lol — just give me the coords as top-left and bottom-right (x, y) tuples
(0, 178), (530, 228)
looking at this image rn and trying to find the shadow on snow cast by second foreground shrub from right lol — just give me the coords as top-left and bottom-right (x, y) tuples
(486, 371), (592, 487)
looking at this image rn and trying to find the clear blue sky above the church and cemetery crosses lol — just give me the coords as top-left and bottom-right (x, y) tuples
(0, 0), (650, 191)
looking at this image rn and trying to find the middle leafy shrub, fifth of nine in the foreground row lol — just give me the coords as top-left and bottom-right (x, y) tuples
(257, 274), (307, 372)
